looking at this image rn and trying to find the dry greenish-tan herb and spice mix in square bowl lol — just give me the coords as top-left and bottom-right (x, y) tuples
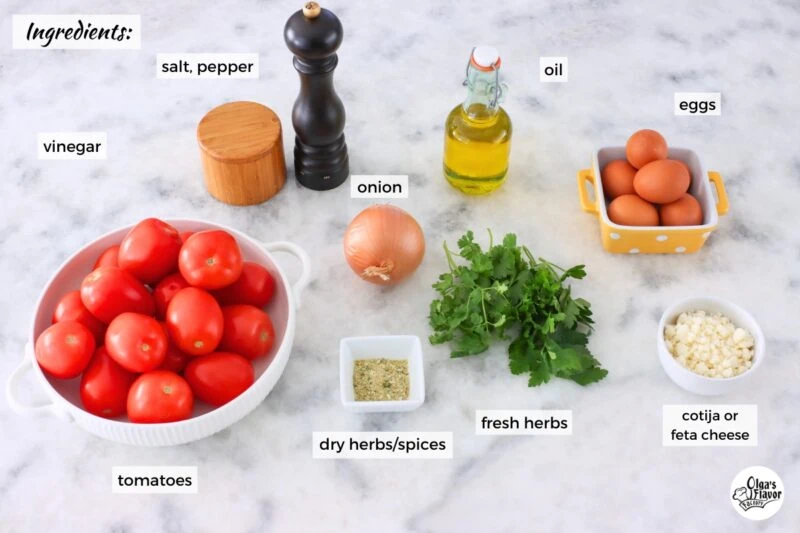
(353, 359), (408, 402)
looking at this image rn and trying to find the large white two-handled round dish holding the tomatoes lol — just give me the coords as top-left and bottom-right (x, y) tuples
(6, 219), (311, 446)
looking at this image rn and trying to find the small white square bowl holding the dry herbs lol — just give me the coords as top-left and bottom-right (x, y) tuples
(339, 335), (425, 413)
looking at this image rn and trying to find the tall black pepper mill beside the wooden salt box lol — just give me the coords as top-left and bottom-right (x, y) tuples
(283, 2), (350, 191)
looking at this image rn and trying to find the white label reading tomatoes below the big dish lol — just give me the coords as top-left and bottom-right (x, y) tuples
(111, 466), (198, 494)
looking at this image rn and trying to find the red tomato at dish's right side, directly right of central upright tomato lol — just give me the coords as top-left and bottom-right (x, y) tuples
(219, 305), (275, 359)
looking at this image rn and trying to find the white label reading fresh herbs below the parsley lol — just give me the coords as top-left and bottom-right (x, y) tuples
(475, 409), (572, 436)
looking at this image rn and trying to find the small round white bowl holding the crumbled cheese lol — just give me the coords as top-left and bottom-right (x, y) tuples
(656, 296), (766, 396)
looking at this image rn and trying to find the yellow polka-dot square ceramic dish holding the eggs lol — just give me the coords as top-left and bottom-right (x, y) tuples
(578, 146), (728, 254)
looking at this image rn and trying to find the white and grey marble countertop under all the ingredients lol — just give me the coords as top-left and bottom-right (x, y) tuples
(0, 0), (800, 533)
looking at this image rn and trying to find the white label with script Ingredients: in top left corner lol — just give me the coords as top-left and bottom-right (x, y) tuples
(11, 15), (142, 50)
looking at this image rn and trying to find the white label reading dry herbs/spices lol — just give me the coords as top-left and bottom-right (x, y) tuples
(312, 431), (453, 459)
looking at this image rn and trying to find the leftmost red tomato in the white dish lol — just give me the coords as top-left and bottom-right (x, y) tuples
(34, 320), (95, 379)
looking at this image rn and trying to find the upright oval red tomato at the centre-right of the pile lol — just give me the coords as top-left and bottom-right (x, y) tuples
(167, 287), (223, 355)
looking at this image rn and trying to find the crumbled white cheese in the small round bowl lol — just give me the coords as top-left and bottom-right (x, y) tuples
(664, 311), (754, 378)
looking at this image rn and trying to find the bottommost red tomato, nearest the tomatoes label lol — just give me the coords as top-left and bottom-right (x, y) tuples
(128, 370), (194, 424)
